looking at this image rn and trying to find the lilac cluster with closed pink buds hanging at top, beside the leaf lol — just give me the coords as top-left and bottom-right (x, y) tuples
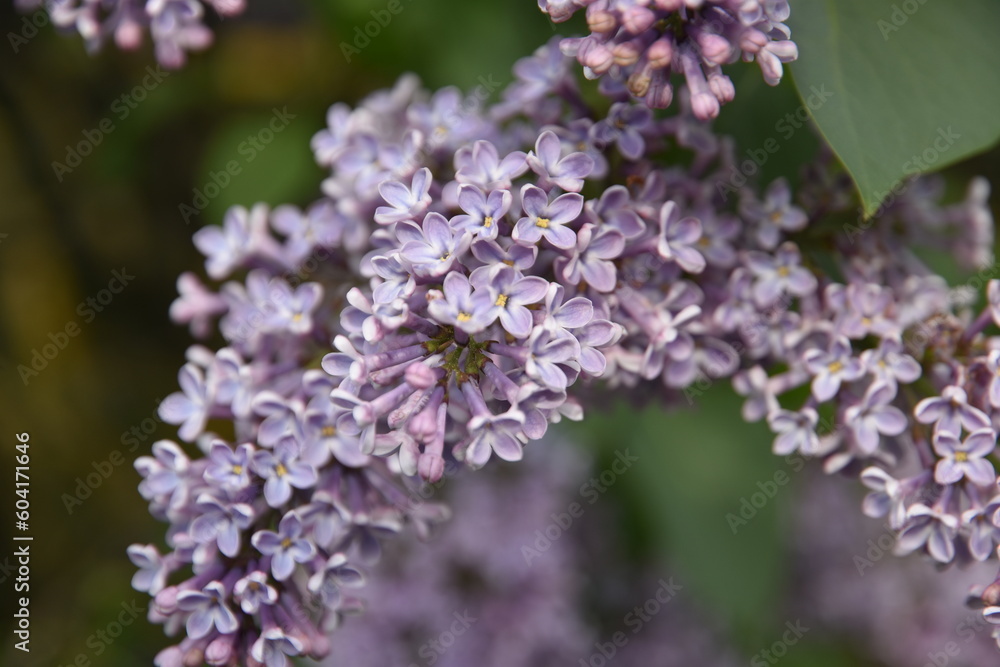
(538, 0), (798, 119)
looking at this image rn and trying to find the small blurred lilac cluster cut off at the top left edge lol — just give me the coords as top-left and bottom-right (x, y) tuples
(14, 0), (246, 68)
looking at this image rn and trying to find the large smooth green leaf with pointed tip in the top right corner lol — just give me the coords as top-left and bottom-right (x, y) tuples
(789, 0), (1000, 215)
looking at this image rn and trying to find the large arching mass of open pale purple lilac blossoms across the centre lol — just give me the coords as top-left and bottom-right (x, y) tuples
(131, 27), (1000, 667)
